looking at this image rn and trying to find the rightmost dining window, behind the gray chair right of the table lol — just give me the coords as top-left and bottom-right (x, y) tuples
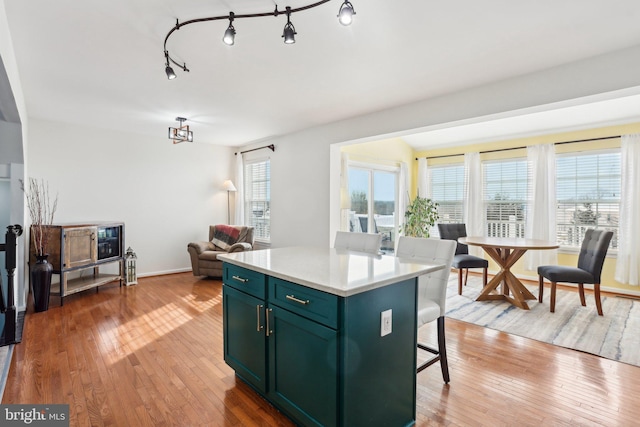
(556, 150), (621, 249)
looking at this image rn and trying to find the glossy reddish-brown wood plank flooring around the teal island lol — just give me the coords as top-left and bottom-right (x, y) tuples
(2, 273), (640, 427)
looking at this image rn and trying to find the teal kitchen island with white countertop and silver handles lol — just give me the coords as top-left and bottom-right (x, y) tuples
(220, 247), (443, 427)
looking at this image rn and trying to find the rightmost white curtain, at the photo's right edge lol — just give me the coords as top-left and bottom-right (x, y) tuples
(615, 134), (640, 286)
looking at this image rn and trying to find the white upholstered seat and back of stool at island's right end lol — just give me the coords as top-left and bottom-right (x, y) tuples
(396, 236), (456, 320)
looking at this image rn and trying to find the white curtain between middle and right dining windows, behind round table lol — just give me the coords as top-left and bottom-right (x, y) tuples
(525, 144), (558, 271)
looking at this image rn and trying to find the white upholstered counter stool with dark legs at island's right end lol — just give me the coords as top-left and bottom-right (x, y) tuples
(396, 236), (456, 383)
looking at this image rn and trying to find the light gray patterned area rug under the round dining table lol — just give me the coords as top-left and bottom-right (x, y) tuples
(447, 273), (640, 366)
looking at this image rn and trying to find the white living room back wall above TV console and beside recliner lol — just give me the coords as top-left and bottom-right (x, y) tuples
(27, 119), (233, 275)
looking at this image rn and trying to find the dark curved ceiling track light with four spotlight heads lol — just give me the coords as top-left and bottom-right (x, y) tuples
(164, 0), (356, 79)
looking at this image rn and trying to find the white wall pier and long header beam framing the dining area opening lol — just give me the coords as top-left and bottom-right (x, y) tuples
(251, 42), (640, 251)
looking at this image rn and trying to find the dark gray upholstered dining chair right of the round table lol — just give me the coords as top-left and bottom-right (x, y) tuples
(538, 228), (613, 316)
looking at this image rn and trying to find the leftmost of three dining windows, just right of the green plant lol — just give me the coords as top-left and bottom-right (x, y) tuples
(428, 164), (464, 237)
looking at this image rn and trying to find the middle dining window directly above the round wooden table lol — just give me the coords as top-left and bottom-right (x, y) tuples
(482, 159), (528, 237)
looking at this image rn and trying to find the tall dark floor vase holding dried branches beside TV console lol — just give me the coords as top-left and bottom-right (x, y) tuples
(22, 178), (58, 312)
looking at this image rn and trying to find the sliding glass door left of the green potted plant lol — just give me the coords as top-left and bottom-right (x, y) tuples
(349, 163), (399, 253)
